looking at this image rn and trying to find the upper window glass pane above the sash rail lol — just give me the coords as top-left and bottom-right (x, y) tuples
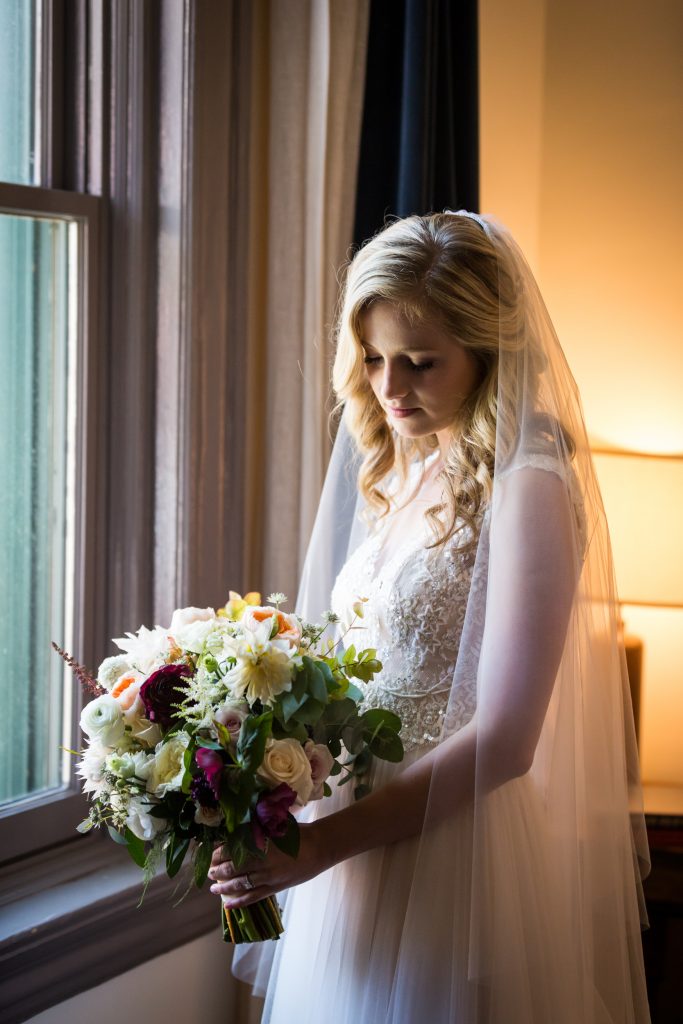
(0, 0), (39, 184)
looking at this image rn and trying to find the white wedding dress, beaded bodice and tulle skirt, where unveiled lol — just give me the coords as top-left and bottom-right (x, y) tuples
(255, 453), (485, 1024)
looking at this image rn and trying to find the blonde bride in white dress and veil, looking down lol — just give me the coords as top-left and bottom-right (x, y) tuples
(206, 210), (649, 1024)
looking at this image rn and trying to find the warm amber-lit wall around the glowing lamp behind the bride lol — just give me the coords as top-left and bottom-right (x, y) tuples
(479, 0), (683, 783)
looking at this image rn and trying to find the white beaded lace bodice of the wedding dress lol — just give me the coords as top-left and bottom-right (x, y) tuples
(332, 456), (485, 751)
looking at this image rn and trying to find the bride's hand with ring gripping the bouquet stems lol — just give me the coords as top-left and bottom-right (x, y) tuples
(209, 822), (331, 907)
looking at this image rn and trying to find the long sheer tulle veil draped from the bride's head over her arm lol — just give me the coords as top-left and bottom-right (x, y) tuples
(236, 211), (649, 1024)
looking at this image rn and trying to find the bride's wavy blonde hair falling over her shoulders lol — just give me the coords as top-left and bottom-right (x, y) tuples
(332, 213), (544, 547)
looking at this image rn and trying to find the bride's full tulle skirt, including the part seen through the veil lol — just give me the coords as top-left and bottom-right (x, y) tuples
(233, 750), (649, 1024)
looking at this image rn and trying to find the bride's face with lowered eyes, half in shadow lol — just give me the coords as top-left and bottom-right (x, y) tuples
(360, 301), (480, 451)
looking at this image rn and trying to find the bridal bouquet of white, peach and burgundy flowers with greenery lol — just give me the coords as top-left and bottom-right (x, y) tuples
(56, 591), (403, 942)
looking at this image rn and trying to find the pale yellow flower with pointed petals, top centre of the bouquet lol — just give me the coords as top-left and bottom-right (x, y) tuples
(224, 620), (294, 705)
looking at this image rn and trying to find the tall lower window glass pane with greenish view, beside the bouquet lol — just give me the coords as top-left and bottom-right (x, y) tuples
(0, 214), (79, 803)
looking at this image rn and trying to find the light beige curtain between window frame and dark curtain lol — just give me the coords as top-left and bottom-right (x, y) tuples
(237, 0), (369, 610)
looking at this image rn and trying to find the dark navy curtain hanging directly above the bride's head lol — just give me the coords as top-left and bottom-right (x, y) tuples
(354, 0), (479, 245)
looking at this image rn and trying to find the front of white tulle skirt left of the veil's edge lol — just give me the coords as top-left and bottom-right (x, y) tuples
(248, 751), (479, 1024)
